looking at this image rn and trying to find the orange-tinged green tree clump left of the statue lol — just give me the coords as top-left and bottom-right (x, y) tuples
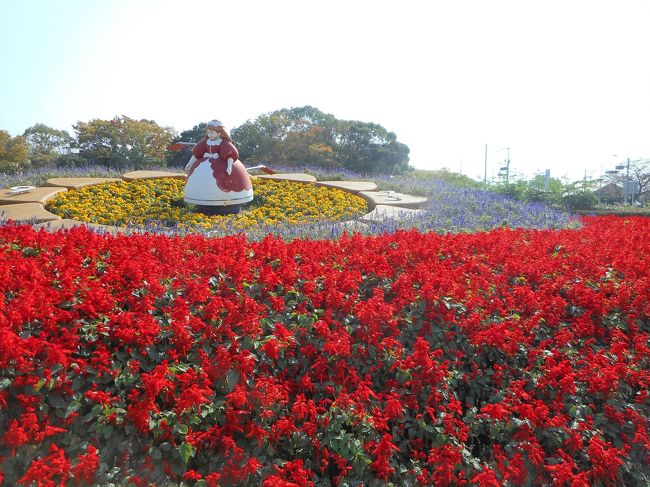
(74, 115), (176, 168)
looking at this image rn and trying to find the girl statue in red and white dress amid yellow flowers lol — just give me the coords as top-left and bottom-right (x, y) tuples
(183, 120), (253, 214)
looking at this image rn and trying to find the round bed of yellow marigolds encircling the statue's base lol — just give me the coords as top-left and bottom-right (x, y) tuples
(47, 178), (367, 231)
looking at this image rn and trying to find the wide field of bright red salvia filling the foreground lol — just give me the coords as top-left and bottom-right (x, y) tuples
(0, 217), (650, 487)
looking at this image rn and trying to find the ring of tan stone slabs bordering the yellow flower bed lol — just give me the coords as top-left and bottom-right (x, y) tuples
(0, 171), (428, 234)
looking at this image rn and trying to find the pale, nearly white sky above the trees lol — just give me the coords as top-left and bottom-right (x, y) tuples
(0, 0), (650, 180)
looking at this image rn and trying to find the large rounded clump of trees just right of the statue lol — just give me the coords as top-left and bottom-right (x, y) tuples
(232, 106), (409, 174)
